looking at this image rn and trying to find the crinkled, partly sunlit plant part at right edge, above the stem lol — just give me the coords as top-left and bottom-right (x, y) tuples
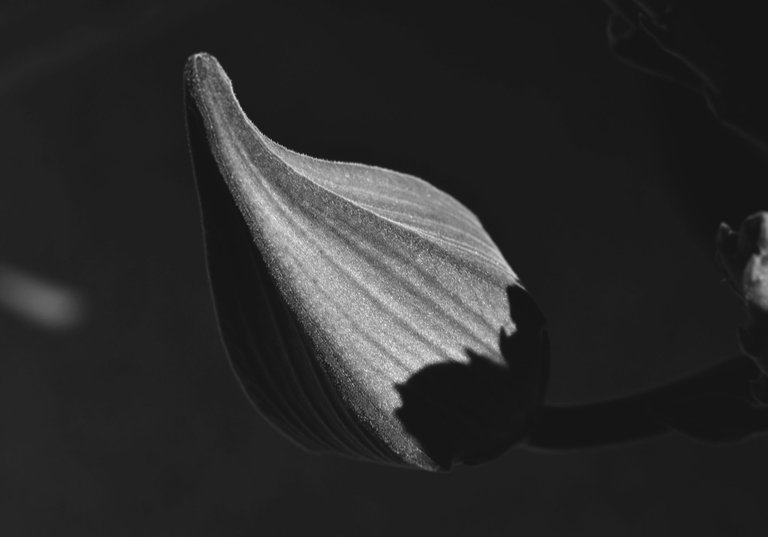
(717, 212), (768, 401)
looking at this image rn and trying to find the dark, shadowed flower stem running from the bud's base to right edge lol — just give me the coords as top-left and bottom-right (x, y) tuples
(526, 355), (768, 451)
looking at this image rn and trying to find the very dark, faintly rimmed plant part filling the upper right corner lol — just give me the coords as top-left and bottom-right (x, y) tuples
(605, 0), (768, 152)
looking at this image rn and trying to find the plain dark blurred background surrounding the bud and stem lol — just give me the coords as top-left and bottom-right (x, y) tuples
(0, 0), (768, 537)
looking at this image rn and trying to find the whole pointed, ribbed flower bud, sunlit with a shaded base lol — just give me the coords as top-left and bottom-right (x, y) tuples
(185, 54), (548, 470)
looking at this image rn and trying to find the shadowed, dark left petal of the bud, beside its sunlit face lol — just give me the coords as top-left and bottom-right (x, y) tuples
(187, 55), (392, 462)
